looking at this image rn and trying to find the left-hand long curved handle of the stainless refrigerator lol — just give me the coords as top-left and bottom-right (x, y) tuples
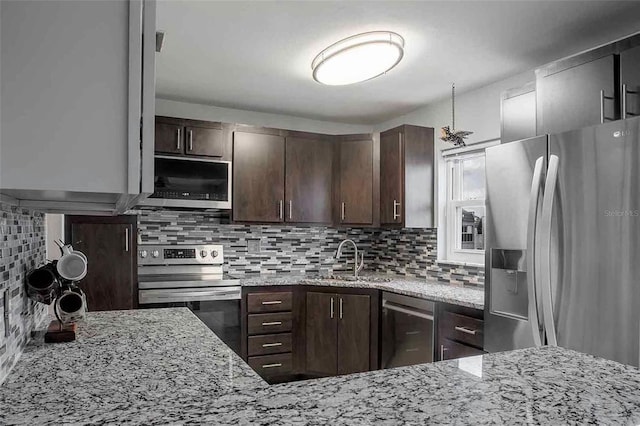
(527, 157), (544, 347)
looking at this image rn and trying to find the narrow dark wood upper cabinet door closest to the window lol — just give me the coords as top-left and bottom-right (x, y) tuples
(380, 131), (404, 225)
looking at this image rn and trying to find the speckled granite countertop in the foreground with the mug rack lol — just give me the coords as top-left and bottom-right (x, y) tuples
(0, 308), (640, 425)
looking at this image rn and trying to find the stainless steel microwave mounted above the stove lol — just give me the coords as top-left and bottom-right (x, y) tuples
(140, 155), (232, 210)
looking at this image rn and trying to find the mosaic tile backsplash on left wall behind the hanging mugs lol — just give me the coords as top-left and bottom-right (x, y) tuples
(0, 203), (48, 383)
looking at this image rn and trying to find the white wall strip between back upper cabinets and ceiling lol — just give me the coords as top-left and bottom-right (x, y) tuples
(156, 98), (373, 135)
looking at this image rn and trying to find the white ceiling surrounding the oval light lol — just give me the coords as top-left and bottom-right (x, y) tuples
(156, 0), (640, 124)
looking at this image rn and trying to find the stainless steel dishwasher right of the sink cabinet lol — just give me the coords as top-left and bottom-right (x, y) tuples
(381, 292), (435, 368)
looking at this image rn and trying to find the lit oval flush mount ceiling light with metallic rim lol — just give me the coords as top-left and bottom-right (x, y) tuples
(311, 31), (404, 86)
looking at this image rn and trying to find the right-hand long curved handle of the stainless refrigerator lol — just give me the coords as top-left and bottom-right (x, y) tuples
(540, 155), (560, 346)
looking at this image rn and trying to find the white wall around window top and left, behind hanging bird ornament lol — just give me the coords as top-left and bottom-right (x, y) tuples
(374, 71), (535, 260)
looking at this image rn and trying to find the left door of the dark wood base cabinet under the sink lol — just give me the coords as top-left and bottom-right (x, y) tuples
(306, 292), (340, 375)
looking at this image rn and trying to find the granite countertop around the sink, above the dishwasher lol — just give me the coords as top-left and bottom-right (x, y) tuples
(238, 273), (484, 309)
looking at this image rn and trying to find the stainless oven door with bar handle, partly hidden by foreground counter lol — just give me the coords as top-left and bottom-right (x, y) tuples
(138, 287), (241, 356)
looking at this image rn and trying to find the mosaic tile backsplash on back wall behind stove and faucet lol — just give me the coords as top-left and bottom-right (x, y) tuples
(136, 210), (484, 286)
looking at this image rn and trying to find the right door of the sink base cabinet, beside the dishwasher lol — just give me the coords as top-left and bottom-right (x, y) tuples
(337, 294), (371, 374)
